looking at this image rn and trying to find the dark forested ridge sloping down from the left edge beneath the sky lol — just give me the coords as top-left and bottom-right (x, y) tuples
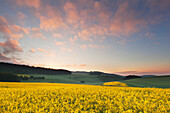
(0, 62), (71, 75)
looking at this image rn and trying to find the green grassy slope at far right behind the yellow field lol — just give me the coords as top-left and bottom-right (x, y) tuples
(121, 76), (170, 88)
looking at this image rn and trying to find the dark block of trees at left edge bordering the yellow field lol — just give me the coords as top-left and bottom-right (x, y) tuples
(0, 73), (20, 82)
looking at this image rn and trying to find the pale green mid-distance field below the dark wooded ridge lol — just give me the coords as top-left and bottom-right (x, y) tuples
(21, 74), (123, 85)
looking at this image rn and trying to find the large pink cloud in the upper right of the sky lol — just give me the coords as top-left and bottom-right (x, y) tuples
(109, 2), (147, 36)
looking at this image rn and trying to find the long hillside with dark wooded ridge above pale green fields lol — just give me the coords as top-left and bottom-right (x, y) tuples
(0, 62), (123, 85)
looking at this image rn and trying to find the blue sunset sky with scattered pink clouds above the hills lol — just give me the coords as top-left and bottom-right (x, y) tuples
(0, 0), (170, 75)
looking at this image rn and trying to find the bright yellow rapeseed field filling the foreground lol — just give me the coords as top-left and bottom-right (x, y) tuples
(0, 82), (170, 113)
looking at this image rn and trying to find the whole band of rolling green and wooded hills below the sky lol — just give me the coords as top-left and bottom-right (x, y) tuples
(0, 62), (170, 88)
